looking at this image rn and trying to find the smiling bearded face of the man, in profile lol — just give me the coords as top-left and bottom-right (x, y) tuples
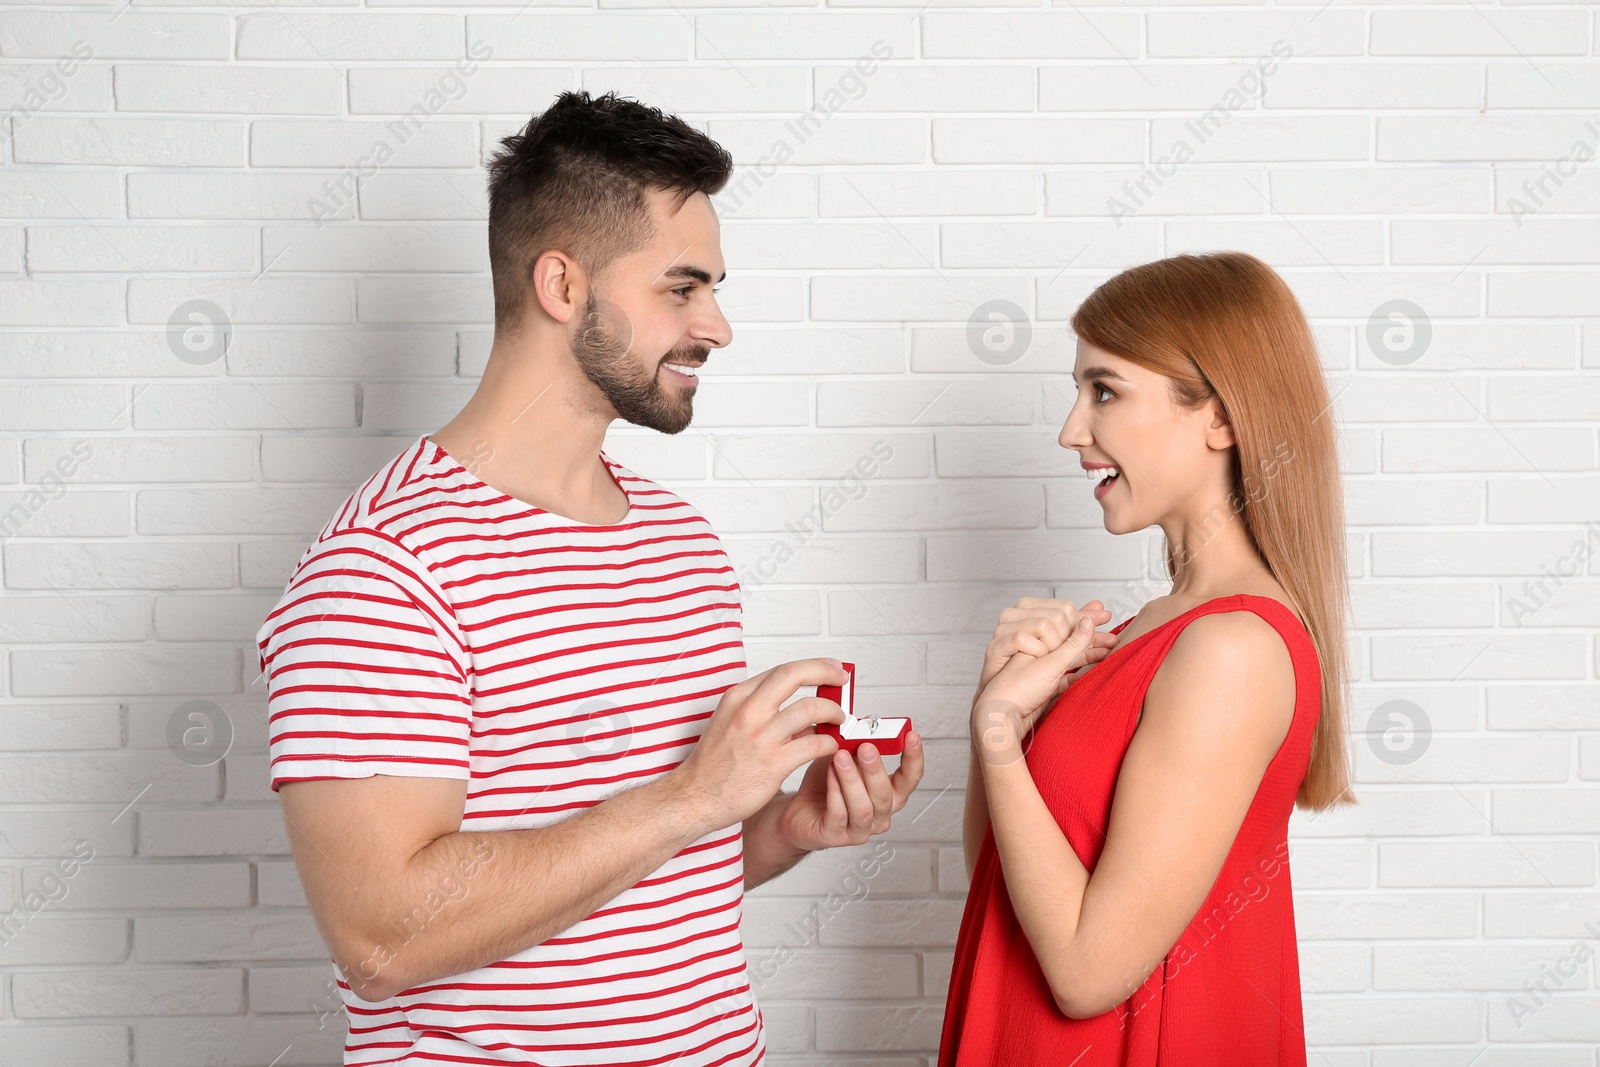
(571, 190), (733, 434)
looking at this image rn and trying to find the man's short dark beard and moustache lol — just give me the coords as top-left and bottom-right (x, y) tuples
(571, 293), (710, 434)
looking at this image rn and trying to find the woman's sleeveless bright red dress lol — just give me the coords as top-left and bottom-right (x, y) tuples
(939, 593), (1322, 1067)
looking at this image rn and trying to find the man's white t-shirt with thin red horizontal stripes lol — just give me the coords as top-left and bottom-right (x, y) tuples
(256, 435), (765, 1067)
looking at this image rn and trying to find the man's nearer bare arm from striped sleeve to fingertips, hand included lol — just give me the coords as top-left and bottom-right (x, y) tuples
(280, 659), (843, 1000)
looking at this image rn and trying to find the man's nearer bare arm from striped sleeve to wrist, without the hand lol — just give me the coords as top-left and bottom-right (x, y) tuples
(278, 774), (710, 1000)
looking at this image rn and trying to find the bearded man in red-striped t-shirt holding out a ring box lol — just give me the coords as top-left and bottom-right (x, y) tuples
(258, 93), (923, 1067)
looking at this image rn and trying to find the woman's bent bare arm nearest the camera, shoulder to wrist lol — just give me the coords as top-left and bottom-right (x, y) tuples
(981, 611), (1294, 1019)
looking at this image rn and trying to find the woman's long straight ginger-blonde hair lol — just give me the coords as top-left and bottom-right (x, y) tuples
(1072, 251), (1350, 809)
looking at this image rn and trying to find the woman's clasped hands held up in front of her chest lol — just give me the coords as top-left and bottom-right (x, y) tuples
(971, 597), (1120, 761)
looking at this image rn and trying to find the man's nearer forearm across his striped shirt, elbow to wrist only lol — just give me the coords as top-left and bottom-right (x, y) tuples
(339, 774), (715, 1000)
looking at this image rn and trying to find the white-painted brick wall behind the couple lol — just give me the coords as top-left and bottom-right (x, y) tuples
(0, 0), (1600, 1067)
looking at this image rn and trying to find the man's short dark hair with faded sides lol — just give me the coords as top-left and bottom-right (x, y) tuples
(488, 90), (733, 331)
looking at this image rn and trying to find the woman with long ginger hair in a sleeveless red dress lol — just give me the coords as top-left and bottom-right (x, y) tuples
(939, 253), (1349, 1067)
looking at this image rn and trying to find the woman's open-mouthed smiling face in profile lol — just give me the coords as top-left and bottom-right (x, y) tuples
(1058, 341), (1234, 533)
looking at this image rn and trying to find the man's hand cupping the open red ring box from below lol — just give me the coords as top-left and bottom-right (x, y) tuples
(778, 731), (923, 851)
